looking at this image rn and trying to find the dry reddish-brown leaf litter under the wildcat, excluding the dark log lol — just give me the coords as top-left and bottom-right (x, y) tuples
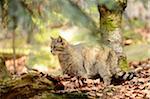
(51, 59), (150, 99)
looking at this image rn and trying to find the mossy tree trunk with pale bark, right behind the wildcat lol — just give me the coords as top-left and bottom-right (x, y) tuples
(98, 0), (128, 71)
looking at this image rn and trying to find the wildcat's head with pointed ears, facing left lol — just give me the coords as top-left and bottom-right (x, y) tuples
(51, 36), (68, 55)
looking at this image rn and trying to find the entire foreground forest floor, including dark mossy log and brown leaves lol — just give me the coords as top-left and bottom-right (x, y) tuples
(0, 58), (150, 99)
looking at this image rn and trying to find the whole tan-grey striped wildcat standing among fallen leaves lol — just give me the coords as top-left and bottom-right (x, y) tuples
(51, 36), (132, 85)
